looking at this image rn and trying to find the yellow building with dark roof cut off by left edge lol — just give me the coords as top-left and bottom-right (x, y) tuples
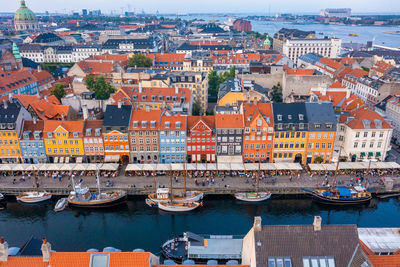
(0, 101), (32, 163)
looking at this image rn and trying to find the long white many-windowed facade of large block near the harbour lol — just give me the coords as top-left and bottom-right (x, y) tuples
(282, 38), (342, 64)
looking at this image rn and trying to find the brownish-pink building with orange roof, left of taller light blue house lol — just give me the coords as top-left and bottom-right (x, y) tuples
(129, 109), (161, 163)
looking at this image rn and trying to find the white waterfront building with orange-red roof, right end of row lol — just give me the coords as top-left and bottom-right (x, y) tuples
(337, 106), (393, 161)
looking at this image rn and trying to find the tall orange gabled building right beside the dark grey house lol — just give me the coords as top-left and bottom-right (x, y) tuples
(241, 103), (274, 162)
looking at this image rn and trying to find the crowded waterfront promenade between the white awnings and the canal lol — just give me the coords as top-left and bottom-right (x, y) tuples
(0, 172), (400, 195)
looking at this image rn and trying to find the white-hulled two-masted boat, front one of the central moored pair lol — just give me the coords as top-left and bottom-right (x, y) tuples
(146, 168), (202, 212)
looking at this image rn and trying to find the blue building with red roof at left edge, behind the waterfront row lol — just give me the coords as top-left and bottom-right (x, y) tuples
(0, 69), (39, 97)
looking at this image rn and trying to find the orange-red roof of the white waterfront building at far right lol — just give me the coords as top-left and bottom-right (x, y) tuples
(346, 106), (392, 129)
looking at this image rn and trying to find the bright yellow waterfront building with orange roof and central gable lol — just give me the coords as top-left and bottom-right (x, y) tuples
(44, 121), (84, 163)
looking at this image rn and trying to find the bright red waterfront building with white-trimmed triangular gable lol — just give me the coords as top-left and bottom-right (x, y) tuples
(186, 116), (216, 163)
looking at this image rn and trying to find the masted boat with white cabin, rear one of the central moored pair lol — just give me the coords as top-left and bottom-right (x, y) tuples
(146, 164), (204, 206)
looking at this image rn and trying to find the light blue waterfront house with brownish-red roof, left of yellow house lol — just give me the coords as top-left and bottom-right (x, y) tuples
(19, 120), (47, 164)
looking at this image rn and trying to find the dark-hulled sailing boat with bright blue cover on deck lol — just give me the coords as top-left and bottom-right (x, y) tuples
(303, 147), (372, 205)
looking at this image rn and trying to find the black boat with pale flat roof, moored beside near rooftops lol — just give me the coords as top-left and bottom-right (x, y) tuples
(161, 232), (243, 264)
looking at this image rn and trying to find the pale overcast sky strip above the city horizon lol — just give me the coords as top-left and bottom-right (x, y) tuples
(0, 0), (400, 13)
